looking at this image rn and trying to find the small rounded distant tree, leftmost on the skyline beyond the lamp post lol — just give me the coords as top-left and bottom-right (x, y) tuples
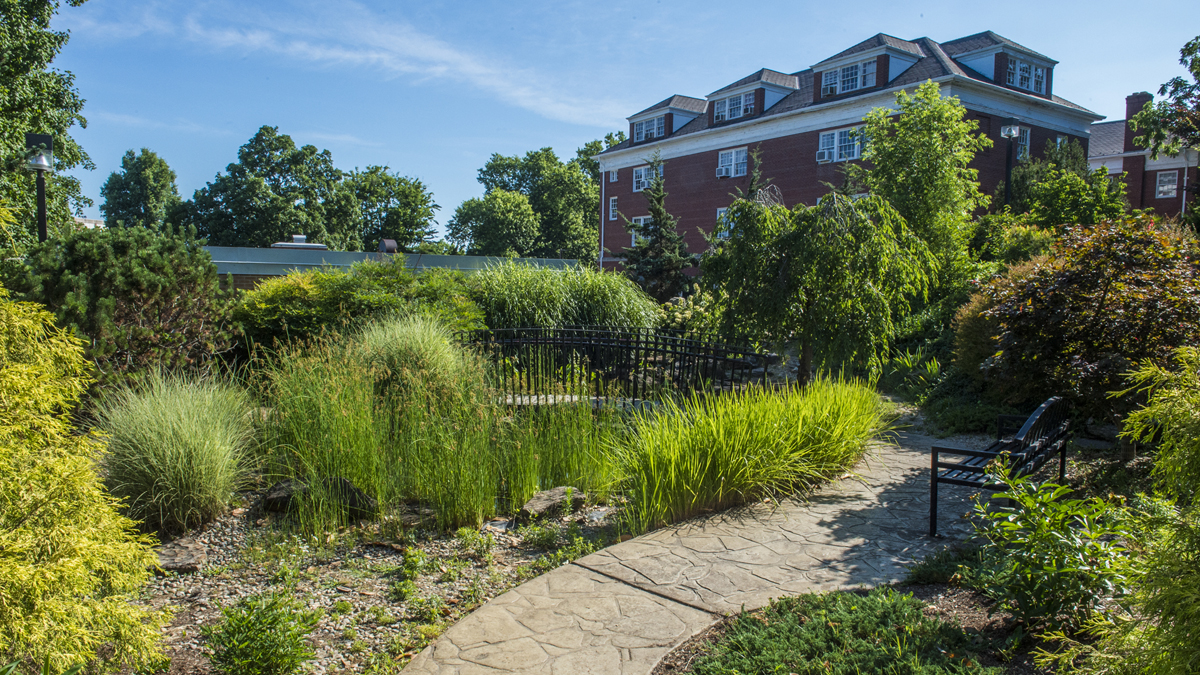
(100, 148), (181, 227)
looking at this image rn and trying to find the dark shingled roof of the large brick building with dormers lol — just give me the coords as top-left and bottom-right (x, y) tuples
(605, 31), (1099, 155)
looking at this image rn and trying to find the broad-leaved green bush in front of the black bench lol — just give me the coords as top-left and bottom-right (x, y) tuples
(967, 462), (1128, 629)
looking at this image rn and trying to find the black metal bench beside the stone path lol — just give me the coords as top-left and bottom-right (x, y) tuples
(929, 396), (1070, 537)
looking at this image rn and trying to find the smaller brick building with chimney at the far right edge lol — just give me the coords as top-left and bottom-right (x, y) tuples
(1087, 91), (1200, 216)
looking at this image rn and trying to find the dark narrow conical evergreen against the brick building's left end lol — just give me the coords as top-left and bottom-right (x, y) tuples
(624, 153), (696, 303)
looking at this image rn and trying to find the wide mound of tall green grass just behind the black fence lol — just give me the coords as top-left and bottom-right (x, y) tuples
(469, 262), (659, 328)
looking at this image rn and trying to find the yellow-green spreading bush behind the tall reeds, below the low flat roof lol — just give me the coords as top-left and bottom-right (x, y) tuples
(234, 258), (482, 345)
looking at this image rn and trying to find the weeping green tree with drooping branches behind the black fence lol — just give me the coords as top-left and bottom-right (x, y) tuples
(702, 193), (936, 383)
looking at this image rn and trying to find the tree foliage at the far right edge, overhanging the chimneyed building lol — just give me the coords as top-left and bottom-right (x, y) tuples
(1129, 36), (1200, 157)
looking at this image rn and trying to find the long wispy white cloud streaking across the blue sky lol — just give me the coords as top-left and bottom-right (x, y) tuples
(71, 2), (624, 129)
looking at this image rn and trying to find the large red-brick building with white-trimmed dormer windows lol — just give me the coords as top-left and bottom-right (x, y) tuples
(596, 31), (1103, 265)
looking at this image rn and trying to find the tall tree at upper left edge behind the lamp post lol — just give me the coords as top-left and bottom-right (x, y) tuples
(0, 0), (95, 249)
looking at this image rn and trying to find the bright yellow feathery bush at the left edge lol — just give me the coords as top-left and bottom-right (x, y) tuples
(0, 288), (168, 673)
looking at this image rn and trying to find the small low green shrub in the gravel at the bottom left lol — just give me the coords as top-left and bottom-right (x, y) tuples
(200, 593), (320, 675)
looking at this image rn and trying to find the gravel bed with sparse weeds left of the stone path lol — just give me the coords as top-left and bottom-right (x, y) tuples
(139, 494), (613, 675)
